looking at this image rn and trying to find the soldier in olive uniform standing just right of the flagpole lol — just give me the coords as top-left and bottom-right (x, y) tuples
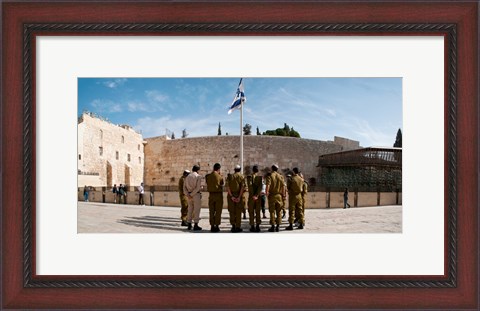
(247, 165), (262, 232)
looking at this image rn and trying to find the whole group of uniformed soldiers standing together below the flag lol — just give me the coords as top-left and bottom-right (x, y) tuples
(179, 163), (308, 233)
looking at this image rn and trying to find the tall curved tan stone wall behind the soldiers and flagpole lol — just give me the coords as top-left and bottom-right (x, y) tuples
(145, 135), (348, 186)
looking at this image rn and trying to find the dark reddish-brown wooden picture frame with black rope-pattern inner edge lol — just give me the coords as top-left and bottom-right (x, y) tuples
(0, 1), (479, 310)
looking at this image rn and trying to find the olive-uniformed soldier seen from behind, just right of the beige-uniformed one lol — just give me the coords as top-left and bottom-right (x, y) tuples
(205, 163), (224, 232)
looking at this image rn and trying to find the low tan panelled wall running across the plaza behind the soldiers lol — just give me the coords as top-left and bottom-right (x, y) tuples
(78, 188), (402, 208)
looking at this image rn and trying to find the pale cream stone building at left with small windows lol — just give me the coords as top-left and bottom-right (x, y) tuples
(77, 113), (145, 188)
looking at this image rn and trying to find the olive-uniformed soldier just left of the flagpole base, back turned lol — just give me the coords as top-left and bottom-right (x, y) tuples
(227, 165), (245, 232)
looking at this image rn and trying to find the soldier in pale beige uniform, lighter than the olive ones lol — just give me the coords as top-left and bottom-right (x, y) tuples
(183, 165), (202, 231)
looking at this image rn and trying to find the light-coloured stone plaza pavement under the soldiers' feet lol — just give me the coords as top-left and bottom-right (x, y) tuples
(77, 202), (402, 234)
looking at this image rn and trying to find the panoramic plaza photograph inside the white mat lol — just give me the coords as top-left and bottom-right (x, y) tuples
(77, 77), (402, 233)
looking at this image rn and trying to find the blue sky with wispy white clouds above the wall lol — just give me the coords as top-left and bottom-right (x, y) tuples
(78, 78), (402, 147)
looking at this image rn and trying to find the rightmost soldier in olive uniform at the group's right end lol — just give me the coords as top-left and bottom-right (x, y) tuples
(285, 167), (304, 230)
